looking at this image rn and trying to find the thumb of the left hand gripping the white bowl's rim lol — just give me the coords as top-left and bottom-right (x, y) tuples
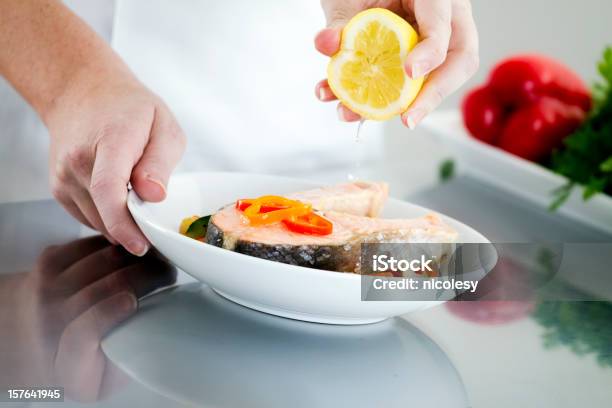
(130, 106), (186, 202)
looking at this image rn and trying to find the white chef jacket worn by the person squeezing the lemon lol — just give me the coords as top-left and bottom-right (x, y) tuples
(0, 0), (382, 201)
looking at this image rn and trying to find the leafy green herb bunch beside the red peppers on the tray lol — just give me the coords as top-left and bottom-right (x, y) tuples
(550, 47), (612, 210)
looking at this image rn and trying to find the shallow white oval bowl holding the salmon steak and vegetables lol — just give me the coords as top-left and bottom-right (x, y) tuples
(128, 172), (489, 324)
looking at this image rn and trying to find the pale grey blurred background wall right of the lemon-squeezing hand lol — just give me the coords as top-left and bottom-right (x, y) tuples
(387, 0), (612, 167)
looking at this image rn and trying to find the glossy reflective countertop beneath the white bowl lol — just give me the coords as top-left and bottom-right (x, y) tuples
(0, 177), (612, 408)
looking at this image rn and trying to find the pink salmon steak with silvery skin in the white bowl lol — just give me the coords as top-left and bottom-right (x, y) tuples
(206, 182), (457, 273)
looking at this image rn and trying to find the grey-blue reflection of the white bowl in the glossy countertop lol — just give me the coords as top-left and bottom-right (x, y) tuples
(103, 283), (469, 407)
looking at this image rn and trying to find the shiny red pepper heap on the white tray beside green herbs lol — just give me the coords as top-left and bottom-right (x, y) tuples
(462, 55), (591, 162)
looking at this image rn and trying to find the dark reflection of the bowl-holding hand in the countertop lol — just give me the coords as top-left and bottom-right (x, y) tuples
(0, 236), (176, 402)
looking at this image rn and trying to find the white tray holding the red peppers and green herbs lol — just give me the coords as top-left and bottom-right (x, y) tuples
(422, 110), (612, 233)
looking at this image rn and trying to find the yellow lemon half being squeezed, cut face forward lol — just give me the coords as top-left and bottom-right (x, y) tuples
(327, 8), (423, 120)
